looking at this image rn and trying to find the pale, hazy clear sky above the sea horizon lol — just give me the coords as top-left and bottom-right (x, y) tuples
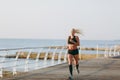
(0, 0), (120, 40)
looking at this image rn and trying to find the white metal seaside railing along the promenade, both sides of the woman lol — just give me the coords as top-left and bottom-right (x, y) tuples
(0, 45), (120, 78)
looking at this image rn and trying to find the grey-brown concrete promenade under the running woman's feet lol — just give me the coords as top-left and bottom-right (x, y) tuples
(5, 58), (120, 80)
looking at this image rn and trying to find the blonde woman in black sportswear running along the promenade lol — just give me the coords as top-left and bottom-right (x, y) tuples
(67, 28), (81, 80)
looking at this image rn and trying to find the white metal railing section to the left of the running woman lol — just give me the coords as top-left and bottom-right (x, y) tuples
(0, 46), (67, 78)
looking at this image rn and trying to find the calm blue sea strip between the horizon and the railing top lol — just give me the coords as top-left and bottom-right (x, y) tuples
(0, 39), (120, 49)
